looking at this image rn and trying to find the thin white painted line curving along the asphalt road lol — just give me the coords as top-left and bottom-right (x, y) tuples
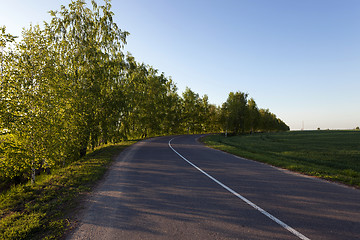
(169, 137), (310, 240)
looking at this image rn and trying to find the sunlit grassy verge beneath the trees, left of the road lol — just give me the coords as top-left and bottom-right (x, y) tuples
(0, 141), (134, 239)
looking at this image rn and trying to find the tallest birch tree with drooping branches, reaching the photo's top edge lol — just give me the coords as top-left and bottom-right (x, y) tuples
(49, 0), (128, 156)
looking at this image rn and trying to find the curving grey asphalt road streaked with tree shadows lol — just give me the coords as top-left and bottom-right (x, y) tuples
(68, 136), (360, 240)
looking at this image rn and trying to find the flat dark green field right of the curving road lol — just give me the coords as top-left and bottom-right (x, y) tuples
(202, 131), (360, 187)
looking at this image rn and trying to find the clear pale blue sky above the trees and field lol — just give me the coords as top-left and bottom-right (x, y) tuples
(0, 0), (360, 130)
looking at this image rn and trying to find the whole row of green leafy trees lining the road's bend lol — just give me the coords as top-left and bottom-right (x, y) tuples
(0, 0), (289, 186)
